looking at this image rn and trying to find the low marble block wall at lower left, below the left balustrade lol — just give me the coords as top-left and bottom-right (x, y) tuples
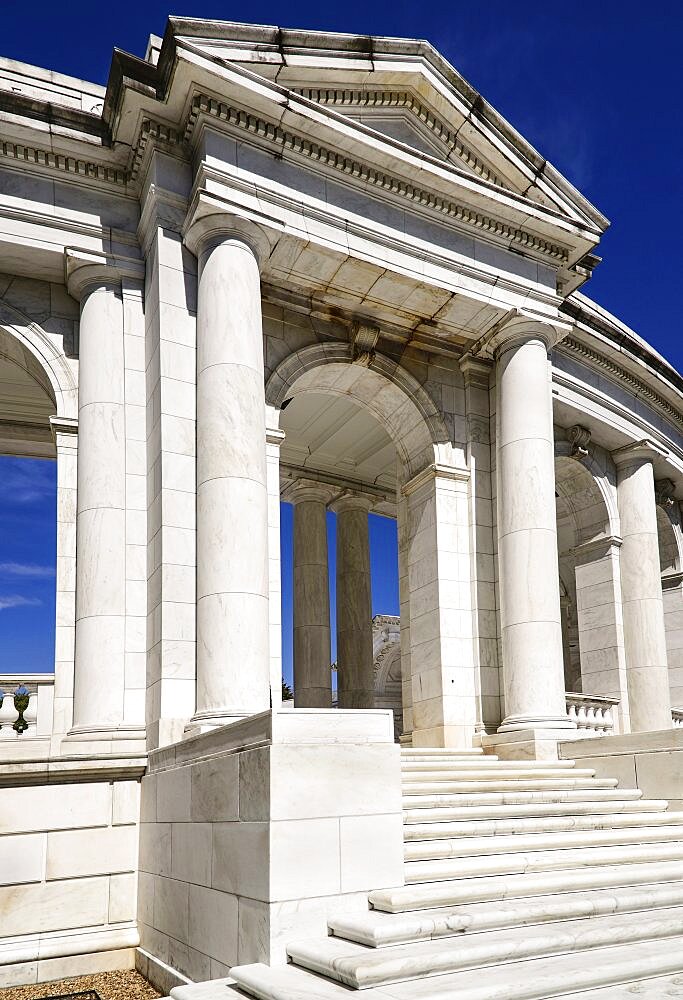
(0, 762), (141, 988)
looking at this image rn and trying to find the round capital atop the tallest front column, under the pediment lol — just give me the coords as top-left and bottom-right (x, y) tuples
(183, 191), (276, 269)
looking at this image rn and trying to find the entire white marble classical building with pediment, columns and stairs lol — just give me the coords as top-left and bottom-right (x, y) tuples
(0, 18), (683, 1000)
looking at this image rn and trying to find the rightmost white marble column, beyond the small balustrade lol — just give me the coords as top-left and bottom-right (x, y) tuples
(612, 441), (671, 733)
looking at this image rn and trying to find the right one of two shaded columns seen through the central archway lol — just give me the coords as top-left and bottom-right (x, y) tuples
(332, 496), (375, 708)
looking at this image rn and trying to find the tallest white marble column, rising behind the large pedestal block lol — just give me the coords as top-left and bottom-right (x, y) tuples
(193, 223), (270, 725)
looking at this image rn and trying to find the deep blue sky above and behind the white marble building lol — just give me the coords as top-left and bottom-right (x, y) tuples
(0, 0), (683, 669)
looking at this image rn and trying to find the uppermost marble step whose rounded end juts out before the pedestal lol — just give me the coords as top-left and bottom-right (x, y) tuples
(368, 859), (683, 913)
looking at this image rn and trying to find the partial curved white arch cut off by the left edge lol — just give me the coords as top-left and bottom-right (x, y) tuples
(0, 298), (78, 417)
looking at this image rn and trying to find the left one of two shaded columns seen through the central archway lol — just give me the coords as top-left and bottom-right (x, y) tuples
(287, 483), (332, 708)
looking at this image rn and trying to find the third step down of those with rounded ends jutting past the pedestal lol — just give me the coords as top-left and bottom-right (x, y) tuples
(287, 906), (683, 990)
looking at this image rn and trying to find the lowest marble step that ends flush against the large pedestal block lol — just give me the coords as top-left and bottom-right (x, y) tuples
(405, 840), (683, 884)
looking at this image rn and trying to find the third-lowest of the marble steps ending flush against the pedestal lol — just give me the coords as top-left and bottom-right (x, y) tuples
(403, 811), (683, 842)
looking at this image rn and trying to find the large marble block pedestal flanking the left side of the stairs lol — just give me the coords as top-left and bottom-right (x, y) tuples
(139, 709), (403, 988)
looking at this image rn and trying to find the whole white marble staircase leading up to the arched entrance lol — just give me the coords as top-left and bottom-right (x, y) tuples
(231, 748), (683, 1000)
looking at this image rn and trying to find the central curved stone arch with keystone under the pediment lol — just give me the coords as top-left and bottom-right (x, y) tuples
(266, 341), (457, 476)
